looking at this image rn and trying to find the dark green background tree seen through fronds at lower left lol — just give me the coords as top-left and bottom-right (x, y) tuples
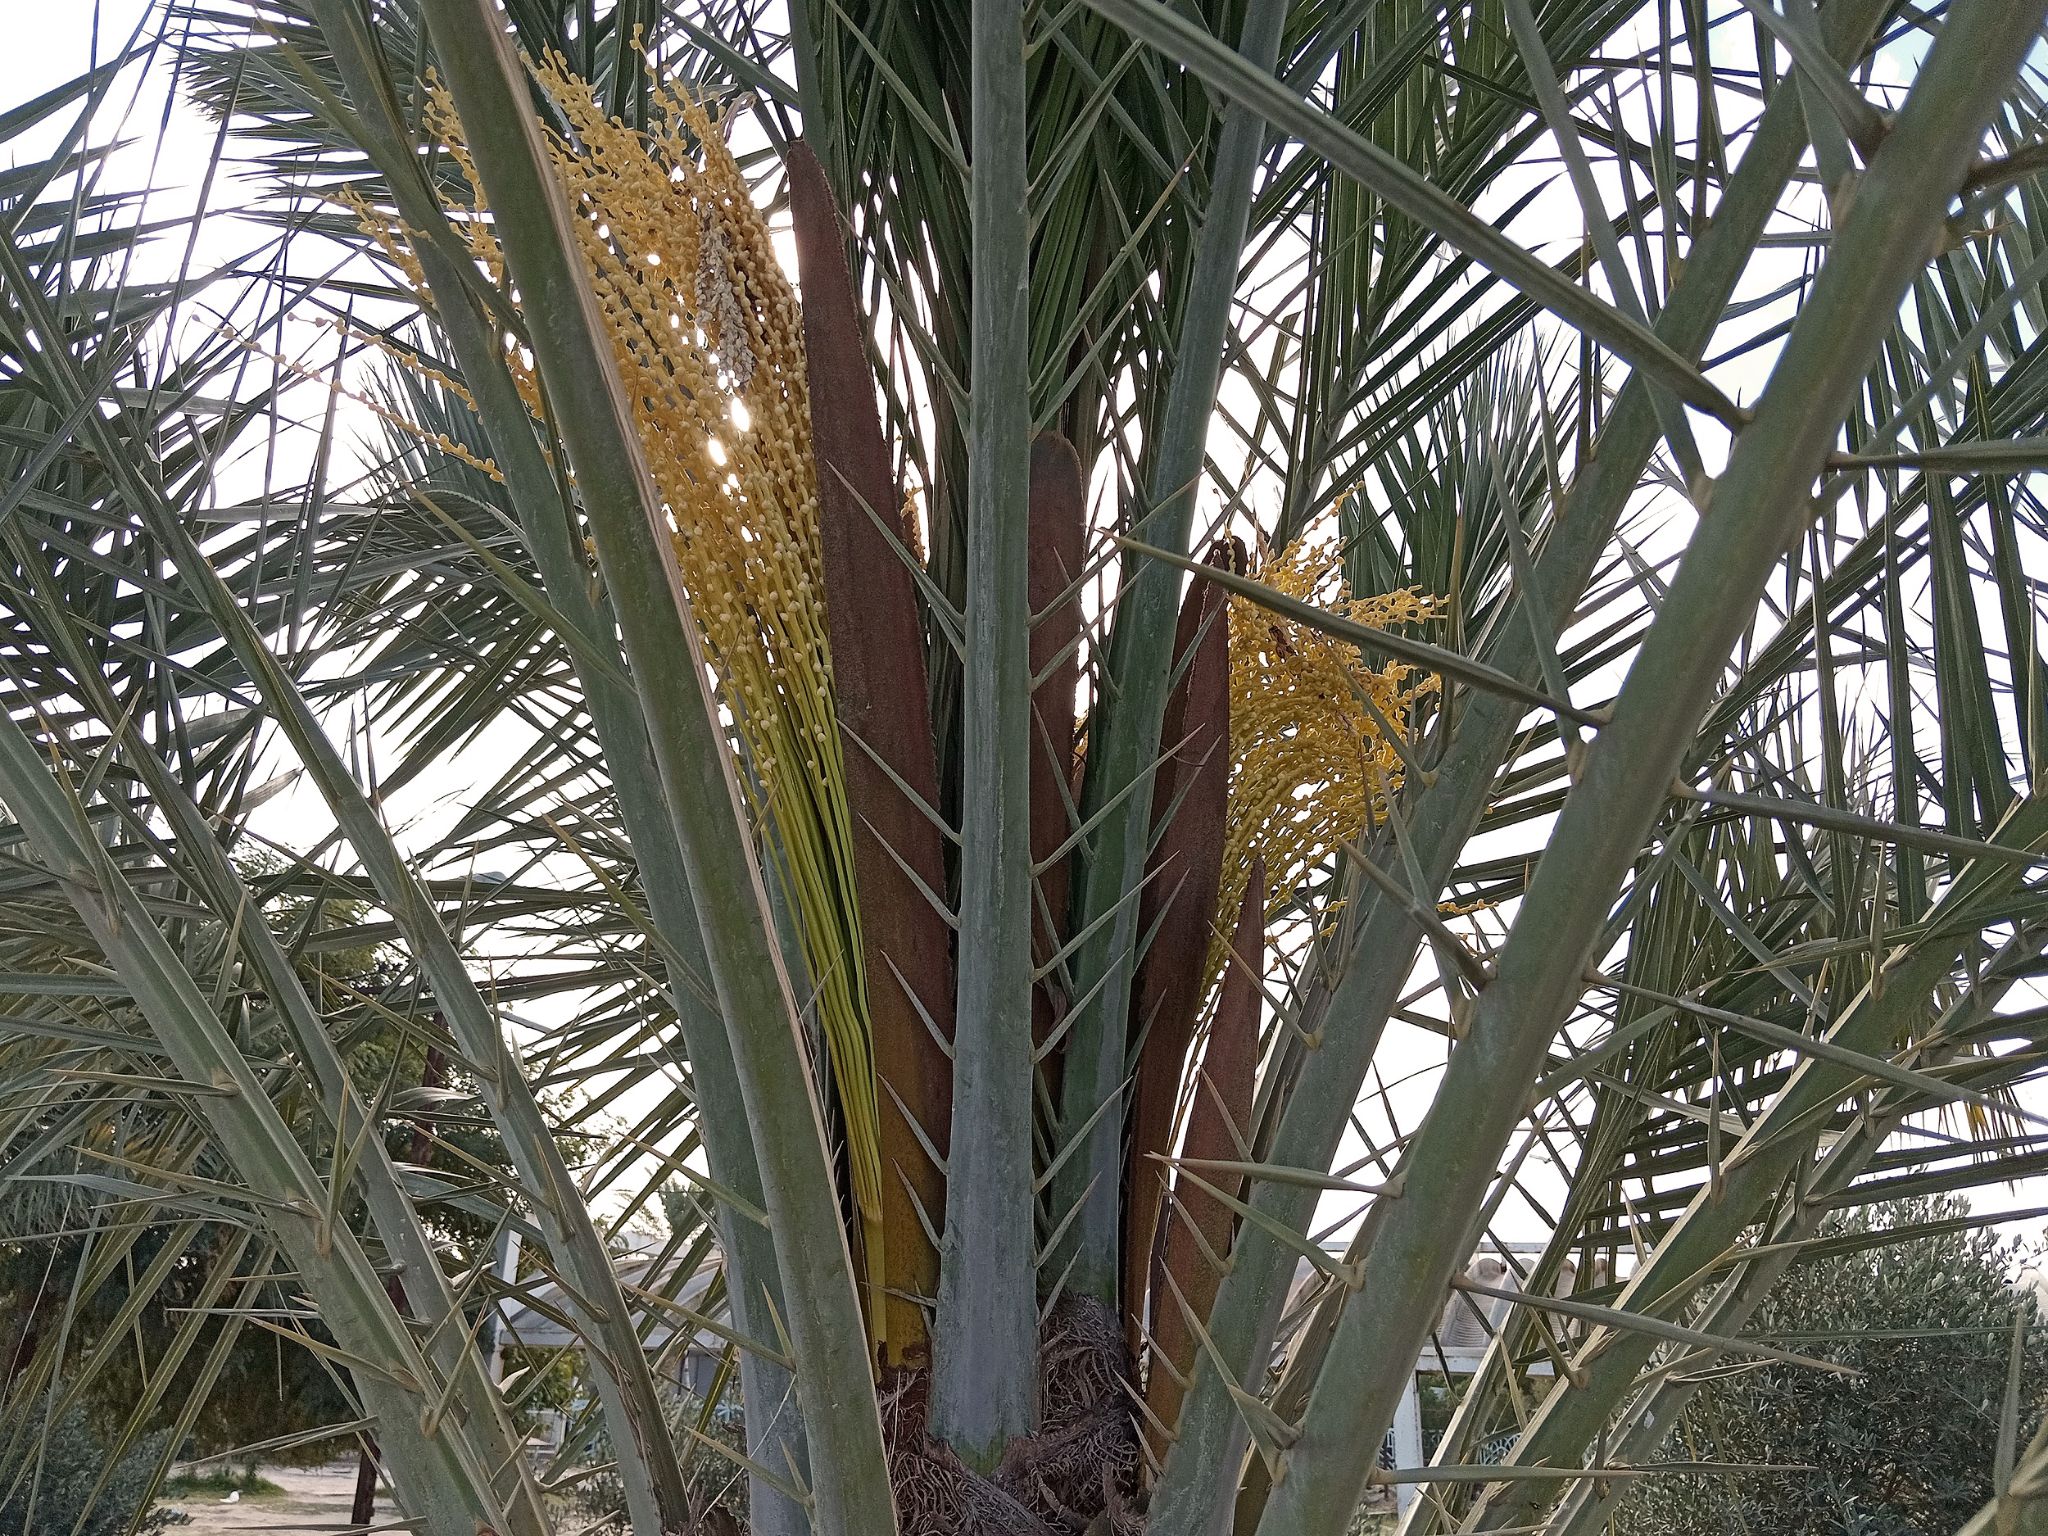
(0, 854), (520, 1526)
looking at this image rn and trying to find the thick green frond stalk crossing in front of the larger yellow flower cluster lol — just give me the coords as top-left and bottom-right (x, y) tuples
(413, 0), (895, 1532)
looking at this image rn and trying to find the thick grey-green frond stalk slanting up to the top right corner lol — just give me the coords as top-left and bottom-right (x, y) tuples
(1260, 0), (2048, 1536)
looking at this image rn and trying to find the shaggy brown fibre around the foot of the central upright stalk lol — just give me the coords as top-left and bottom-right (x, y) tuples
(883, 1296), (1145, 1536)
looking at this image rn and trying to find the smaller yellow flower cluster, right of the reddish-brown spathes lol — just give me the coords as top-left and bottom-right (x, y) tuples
(1206, 532), (1438, 981)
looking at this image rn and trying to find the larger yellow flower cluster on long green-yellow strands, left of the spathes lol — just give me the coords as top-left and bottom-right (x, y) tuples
(391, 55), (881, 1217)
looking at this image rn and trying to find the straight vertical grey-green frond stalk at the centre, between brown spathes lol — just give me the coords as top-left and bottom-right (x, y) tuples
(932, 0), (1038, 1473)
